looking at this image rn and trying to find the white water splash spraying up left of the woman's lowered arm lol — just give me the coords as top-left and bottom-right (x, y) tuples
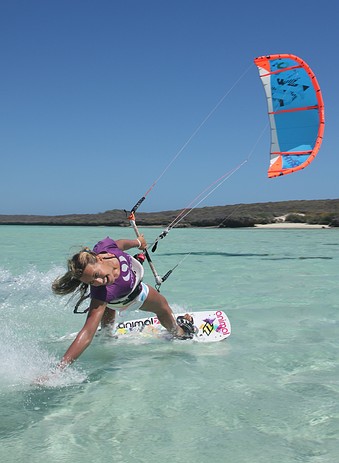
(0, 267), (86, 392)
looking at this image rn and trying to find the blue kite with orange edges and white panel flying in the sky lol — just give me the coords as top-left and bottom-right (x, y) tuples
(254, 54), (325, 177)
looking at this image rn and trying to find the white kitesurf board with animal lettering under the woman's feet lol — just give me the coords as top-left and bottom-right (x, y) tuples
(59, 310), (231, 342)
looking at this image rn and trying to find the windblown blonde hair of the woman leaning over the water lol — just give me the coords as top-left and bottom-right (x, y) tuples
(52, 248), (97, 307)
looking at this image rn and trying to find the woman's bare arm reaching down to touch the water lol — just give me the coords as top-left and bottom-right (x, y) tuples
(58, 299), (107, 369)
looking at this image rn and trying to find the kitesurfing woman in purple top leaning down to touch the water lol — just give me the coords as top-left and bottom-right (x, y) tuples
(52, 235), (194, 369)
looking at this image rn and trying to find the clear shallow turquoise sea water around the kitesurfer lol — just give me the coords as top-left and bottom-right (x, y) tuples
(0, 226), (339, 463)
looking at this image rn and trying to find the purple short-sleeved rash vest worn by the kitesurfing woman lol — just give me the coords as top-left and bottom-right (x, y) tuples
(91, 237), (135, 302)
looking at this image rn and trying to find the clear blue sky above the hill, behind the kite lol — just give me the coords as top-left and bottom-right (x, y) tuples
(0, 0), (339, 215)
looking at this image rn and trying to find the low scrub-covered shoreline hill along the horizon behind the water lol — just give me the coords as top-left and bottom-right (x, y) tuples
(0, 199), (339, 228)
